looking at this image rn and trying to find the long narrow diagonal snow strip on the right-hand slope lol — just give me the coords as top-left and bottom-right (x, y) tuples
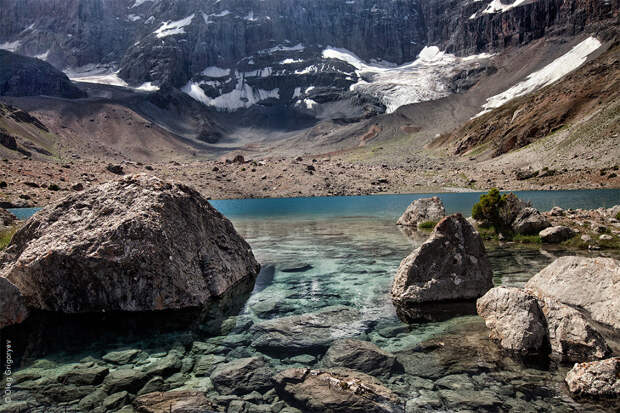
(476, 37), (601, 117)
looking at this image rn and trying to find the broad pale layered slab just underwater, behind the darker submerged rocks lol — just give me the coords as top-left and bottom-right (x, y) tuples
(250, 306), (364, 355)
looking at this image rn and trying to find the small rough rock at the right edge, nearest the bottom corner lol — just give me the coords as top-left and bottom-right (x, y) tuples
(565, 357), (620, 398)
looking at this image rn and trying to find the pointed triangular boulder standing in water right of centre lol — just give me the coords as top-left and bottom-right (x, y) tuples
(392, 214), (493, 307)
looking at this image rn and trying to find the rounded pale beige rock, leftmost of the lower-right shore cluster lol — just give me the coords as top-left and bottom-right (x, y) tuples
(476, 287), (547, 354)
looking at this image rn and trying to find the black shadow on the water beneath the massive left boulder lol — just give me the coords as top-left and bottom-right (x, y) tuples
(0, 279), (255, 368)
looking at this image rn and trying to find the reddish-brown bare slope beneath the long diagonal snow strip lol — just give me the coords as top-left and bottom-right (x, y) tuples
(430, 42), (620, 158)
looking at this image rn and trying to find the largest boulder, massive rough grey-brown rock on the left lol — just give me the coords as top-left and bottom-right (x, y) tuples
(0, 175), (259, 313)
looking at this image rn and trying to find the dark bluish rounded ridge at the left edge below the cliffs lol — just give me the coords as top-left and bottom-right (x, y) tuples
(0, 50), (86, 98)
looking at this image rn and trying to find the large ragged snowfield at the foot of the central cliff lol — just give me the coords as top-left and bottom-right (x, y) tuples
(324, 46), (490, 113)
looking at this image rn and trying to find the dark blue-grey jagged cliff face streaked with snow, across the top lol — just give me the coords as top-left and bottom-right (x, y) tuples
(0, 0), (619, 113)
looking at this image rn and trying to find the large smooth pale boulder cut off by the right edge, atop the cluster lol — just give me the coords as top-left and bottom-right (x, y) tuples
(526, 257), (620, 329)
